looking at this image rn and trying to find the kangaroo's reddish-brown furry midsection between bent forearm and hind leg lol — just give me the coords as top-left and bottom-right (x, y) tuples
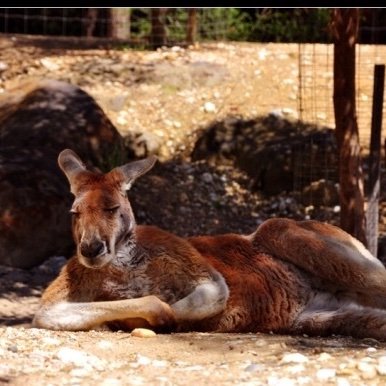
(184, 234), (306, 332)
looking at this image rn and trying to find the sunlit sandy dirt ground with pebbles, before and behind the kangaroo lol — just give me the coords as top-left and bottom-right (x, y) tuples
(0, 37), (386, 386)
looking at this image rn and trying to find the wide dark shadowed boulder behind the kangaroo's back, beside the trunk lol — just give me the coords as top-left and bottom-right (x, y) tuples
(192, 114), (338, 201)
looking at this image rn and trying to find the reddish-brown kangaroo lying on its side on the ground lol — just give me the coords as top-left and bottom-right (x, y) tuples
(33, 149), (386, 340)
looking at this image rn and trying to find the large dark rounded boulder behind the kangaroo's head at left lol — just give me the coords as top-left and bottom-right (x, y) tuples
(0, 80), (125, 268)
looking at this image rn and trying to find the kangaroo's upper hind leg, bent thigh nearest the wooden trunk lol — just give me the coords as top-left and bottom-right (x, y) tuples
(253, 218), (386, 308)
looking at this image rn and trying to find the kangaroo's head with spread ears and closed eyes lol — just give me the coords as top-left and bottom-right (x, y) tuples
(58, 149), (156, 268)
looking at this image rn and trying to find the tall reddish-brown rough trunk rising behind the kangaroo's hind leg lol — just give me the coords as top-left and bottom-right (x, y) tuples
(332, 8), (367, 245)
